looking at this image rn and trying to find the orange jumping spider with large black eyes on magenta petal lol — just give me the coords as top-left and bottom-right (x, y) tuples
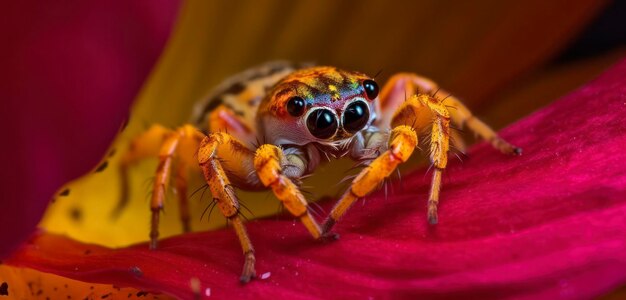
(120, 62), (521, 283)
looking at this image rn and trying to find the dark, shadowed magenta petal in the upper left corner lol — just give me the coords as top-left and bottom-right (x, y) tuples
(0, 0), (179, 258)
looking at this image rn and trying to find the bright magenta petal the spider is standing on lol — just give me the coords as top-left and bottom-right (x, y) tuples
(8, 61), (626, 299)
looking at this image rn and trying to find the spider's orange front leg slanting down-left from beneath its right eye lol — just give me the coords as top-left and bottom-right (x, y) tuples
(322, 125), (417, 234)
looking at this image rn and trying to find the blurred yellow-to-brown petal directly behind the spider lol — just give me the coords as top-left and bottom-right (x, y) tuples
(36, 0), (606, 247)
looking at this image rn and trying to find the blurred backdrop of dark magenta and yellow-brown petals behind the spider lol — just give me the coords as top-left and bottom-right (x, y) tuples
(0, 0), (626, 255)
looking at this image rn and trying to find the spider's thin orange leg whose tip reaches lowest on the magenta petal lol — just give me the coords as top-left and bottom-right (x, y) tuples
(198, 132), (256, 283)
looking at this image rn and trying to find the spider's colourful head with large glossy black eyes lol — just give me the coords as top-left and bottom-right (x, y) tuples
(257, 67), (379, 149)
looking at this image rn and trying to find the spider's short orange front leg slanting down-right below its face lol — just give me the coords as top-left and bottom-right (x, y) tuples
(254, 144), (326, 239)
